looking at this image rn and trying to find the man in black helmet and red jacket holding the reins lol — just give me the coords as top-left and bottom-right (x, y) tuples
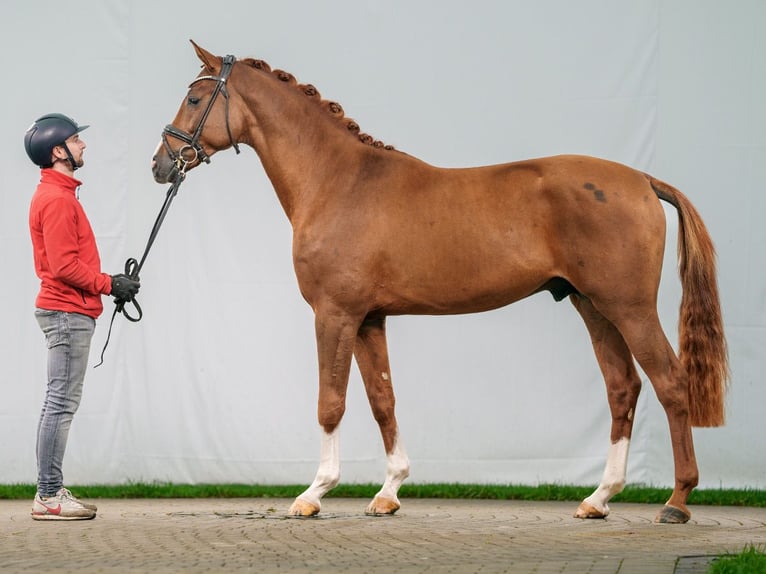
(24, 114), (140, 520)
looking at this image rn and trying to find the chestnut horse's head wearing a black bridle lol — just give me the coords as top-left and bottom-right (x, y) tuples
(152, 41), (239, 183)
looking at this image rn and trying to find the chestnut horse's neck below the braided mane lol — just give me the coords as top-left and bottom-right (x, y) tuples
(244, 72), (364, 225)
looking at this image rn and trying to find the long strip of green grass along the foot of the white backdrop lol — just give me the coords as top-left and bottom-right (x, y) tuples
(0, 482), (766, 507)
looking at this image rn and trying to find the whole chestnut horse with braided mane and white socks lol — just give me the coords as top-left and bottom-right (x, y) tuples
(152, 42), (729, 523)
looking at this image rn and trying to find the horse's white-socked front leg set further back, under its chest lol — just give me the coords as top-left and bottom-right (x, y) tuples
(354, 317), (410, 515)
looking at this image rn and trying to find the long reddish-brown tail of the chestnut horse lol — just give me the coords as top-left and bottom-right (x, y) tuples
(645, 174), (729, 427)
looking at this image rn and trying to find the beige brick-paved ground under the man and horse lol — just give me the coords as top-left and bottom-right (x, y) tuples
(0, 498), (766, 574)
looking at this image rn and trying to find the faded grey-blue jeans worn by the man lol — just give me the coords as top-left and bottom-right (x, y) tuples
(35, 309), (96, 496)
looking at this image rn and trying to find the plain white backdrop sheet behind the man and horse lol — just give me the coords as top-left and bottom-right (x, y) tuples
(0, 0), (766, 488)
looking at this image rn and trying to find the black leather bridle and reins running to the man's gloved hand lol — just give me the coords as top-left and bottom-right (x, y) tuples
(94, 55), (239, 368)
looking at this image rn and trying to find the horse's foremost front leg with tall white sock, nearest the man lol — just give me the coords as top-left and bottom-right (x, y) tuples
(288, 311), (359, 516)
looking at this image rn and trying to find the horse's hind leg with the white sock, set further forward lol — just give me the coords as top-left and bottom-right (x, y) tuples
(570, 295), (641, 518)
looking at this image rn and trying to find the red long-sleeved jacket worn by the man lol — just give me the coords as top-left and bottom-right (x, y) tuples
(29, 169), (112, 319)
